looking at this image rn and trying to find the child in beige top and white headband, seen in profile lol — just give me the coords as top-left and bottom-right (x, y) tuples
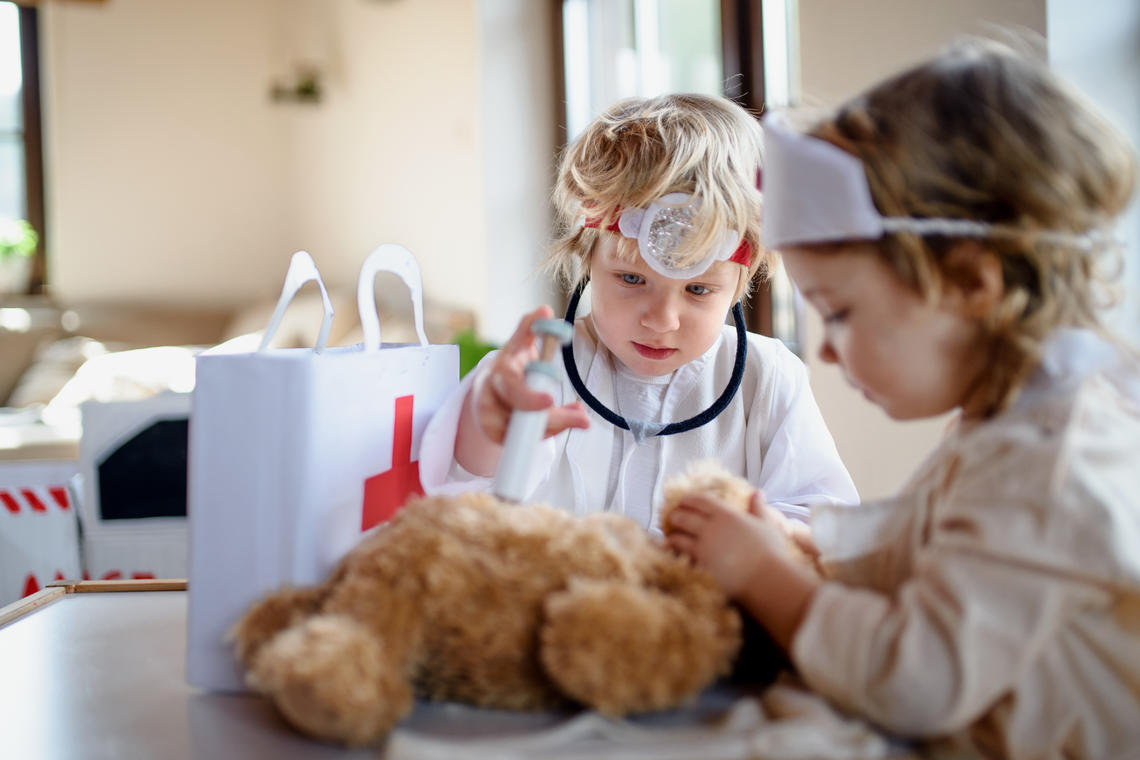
(669, 40), (1140, 759)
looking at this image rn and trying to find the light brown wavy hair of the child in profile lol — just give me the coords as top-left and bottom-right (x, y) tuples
(811, 38), (1137, 416)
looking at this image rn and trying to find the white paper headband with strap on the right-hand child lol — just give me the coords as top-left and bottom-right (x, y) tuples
(762, 114), (1105, 250)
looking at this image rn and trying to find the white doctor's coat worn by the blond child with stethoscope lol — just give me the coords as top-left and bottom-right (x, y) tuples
(420, 320), (858, 530)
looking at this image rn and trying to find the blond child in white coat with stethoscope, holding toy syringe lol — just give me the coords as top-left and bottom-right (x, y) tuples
(420, 95), (858, 529)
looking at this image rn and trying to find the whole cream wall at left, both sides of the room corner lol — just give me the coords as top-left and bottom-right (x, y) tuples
(41, 0), (488, 312)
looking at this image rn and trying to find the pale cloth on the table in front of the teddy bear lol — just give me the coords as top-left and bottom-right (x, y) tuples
(384, 681), (918, 760)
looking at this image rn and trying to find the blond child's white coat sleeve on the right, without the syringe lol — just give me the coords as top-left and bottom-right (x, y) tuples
(749, 341), (858, 521)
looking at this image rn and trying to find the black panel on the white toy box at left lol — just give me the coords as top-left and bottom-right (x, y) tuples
(99, 418), (189, 520)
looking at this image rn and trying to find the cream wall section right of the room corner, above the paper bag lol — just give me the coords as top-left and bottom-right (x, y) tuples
(279, 0), (487, 305)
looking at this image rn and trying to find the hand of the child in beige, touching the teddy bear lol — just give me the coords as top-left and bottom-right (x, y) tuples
(668, 491), (811, 597)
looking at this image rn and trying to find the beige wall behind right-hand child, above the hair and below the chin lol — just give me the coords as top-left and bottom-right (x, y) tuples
(799, 0), (1048, 499)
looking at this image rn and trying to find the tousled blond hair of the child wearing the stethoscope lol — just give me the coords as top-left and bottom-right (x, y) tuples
(545, 95), (768, 299)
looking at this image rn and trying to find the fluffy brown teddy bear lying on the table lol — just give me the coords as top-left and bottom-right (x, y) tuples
(230, 467), (784, 745)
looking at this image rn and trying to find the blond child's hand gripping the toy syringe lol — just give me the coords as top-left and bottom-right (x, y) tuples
(471, 307), (589, 444)
